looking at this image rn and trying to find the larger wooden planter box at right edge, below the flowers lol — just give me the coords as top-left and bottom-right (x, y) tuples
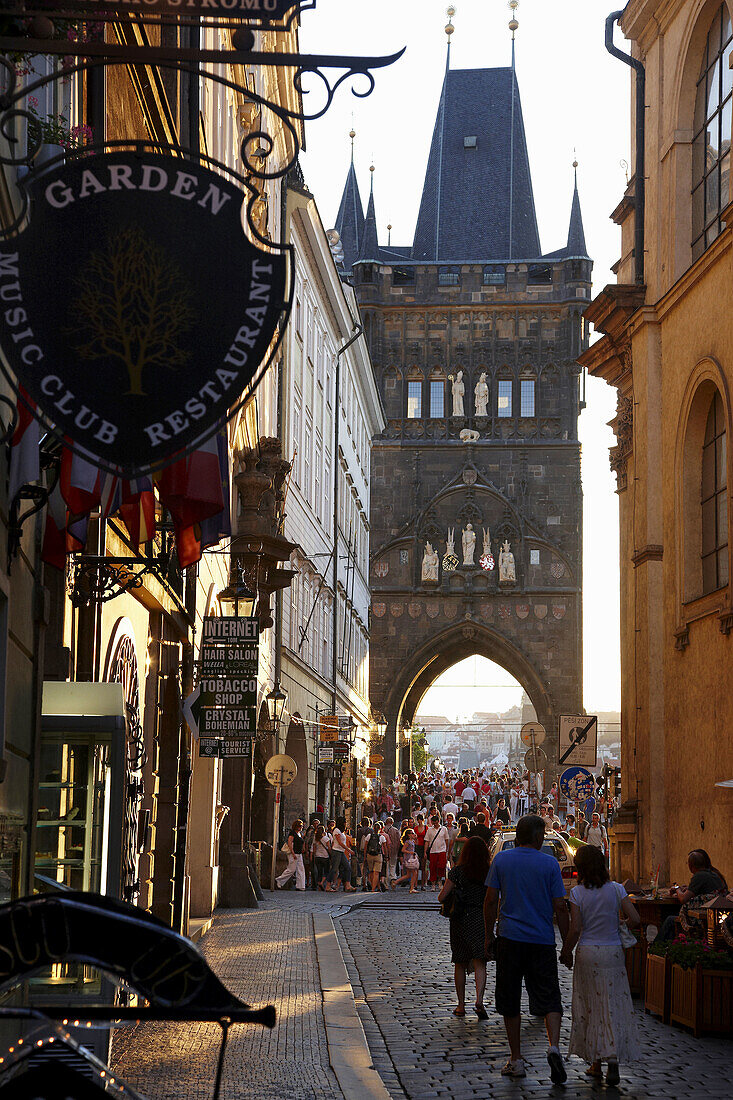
(669, 953), (733, 1038)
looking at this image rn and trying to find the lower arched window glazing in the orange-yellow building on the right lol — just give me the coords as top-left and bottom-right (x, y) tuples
(700, 389), (729, 593)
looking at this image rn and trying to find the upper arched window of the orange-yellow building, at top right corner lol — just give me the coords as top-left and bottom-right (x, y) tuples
(692, 3), (733, 260)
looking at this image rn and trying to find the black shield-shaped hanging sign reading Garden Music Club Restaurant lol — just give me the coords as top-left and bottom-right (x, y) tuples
(0, 154), (288, 479)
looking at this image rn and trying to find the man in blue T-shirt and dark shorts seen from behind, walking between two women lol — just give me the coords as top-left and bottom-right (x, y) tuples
(483, 814), (570, 1085)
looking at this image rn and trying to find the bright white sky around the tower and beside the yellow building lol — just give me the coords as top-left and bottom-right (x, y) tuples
(300, 0), (630, 713)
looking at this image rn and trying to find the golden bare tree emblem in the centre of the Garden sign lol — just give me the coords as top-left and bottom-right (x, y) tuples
(74, 226), (195, 397)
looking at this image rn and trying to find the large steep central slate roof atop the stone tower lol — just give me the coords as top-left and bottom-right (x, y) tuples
(413, 68), (540, 262)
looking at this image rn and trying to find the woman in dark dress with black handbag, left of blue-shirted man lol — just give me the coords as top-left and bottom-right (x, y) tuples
(438, 836), (489, 1020)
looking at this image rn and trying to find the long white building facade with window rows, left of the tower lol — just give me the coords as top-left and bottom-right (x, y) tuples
(282, 183), (384, 821)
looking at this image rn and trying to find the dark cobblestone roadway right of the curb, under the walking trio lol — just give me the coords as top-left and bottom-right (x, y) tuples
(337, 893), (733, 1100)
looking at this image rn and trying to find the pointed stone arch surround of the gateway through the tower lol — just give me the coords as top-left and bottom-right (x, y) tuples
(380, 623), (558, 776)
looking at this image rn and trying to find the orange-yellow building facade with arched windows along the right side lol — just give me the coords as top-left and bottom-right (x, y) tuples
(581, 0), (733, 882)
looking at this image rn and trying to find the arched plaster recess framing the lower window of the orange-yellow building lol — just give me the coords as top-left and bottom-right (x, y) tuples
(675, 359), (733, 649)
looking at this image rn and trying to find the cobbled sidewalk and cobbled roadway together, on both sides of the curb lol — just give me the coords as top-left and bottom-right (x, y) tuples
(113, 892), (733, 1100)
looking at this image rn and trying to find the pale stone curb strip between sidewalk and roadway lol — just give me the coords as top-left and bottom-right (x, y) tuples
(313, 913), (390, 1100)
